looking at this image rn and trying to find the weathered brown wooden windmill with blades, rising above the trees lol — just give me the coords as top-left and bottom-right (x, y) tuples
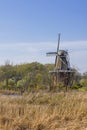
(47, 34), (73, 87)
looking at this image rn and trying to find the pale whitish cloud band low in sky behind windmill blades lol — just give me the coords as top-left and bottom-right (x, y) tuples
(0, 41), (87, 72)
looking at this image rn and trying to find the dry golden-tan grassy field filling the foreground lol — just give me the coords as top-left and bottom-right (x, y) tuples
(0, 91), (87, 130)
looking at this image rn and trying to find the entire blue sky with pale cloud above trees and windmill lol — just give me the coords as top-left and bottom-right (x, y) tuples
(0, 0), (87, 73)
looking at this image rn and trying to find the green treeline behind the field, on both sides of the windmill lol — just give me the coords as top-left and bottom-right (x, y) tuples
(0, 62), (87, 91)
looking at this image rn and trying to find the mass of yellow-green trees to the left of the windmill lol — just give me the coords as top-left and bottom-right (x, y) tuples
(0, 62), (49, 90)
